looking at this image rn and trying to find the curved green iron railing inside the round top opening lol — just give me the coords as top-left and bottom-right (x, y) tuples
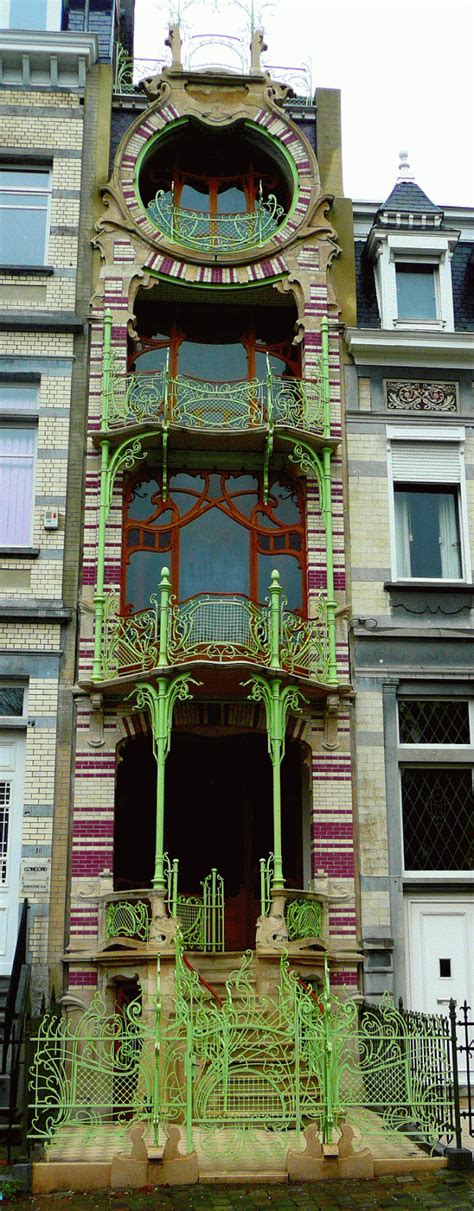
(147, 188), (285, 253)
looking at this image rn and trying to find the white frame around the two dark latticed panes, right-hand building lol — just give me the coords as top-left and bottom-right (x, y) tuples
(396, 688), (474, 884)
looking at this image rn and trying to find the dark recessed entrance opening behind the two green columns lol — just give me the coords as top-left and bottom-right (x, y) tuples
(114, 733), (303, 951)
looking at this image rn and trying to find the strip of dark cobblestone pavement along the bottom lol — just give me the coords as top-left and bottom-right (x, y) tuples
(9, 1170), (474, 1211)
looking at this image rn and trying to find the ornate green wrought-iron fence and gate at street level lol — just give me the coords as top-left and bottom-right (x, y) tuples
(30, 935), (453, 1155)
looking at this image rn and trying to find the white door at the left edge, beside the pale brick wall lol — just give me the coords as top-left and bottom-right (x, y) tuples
(0, 731), (24, 975)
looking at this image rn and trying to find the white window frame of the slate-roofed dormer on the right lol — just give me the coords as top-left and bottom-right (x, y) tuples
(373, 229), (457, 332)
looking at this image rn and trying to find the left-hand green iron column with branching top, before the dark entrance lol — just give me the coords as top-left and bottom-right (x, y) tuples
(129, 673), (196, 894)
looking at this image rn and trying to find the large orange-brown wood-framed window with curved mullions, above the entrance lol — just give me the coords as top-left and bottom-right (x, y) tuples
(122, 471), (305, 613)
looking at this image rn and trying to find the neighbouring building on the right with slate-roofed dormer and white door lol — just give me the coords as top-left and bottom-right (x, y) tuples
(345, 161), (474, 1012)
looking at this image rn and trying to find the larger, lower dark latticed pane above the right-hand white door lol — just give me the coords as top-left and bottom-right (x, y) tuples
(401, 768), (474, 871)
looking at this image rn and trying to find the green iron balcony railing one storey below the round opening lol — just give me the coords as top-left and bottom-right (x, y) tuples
(102, 366), (330, 437)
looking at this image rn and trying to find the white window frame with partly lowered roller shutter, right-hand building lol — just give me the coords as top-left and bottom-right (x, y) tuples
(387, 425), (472, 590)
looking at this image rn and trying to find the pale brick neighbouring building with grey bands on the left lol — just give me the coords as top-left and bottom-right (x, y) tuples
(0, 0), (110, 1005)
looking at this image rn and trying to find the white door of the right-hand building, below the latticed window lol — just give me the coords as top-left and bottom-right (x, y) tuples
(409, 896), (474, 1073)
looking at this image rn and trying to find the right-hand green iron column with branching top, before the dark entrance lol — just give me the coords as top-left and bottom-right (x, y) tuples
(242, 673), (307, 891)
